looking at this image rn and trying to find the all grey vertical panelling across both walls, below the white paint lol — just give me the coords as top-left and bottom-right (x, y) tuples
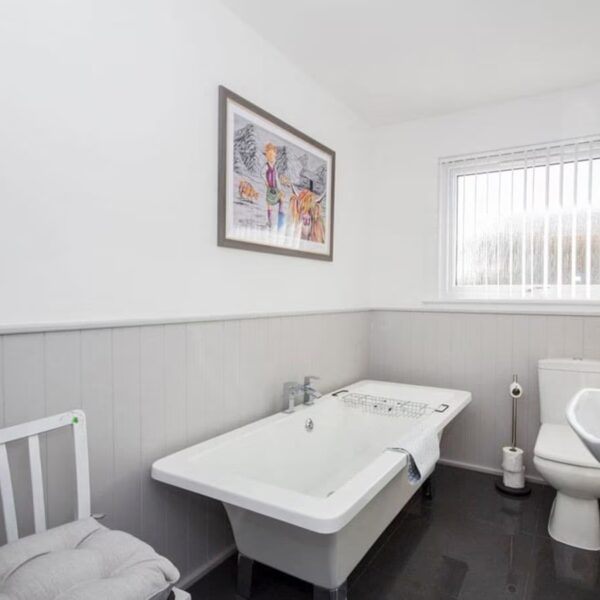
(0, 310), (600, 579)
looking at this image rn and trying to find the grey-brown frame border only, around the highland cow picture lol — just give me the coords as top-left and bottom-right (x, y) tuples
(217, 85), (335, 262)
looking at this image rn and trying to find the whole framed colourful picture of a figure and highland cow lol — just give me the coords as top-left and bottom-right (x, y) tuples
(218, 86), (335, 261)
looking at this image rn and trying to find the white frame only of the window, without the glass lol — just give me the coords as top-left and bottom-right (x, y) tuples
(437, 135), (600, 305)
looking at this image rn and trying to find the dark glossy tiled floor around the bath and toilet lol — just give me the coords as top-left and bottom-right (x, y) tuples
(192, 466), (600, 600)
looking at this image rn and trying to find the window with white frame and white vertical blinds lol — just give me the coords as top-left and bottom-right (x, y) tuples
(440, 137), (600, 300)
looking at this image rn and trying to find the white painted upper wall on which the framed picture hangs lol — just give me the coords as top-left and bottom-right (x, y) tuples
(0, 0), (368, 325)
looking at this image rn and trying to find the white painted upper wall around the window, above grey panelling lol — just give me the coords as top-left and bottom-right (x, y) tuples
(370, 84), (600, 307)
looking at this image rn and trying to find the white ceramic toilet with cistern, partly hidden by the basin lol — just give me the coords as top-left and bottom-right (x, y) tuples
(533, 358), (600, 550)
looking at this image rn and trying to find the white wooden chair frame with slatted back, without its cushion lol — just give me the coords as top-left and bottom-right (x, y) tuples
(0, 410), (191, 600)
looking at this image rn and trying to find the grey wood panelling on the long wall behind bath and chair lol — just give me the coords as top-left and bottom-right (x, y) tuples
(0, 311), (371, 581)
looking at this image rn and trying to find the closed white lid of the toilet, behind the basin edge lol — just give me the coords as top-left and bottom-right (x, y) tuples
(534, 423), (600, 469)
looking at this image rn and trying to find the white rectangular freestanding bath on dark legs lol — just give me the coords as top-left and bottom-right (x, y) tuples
(152, 381), (471, 599)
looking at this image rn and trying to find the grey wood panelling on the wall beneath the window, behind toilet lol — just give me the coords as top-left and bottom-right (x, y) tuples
(369, 311), (600, 476)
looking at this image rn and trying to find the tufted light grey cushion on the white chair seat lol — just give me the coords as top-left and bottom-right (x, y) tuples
(0, 518), (179, 600)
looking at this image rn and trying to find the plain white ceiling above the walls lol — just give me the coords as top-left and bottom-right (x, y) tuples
(221, 0), (600, 124)
